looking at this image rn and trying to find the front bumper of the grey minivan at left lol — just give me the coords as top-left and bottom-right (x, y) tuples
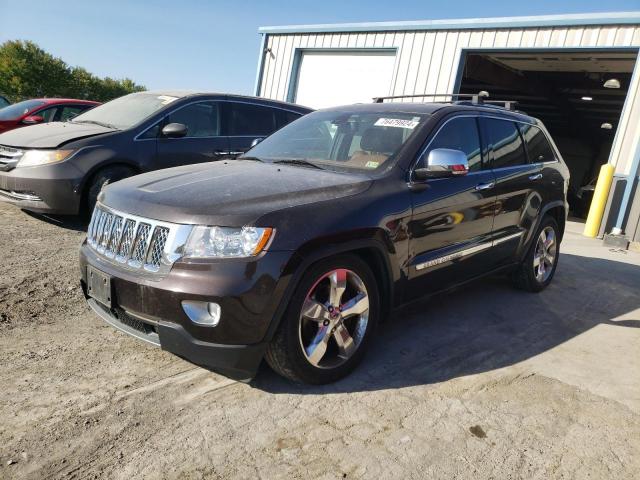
(0, 162), (83, 215)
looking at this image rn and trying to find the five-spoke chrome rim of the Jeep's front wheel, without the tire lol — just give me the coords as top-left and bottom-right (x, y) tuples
(298, 268), (369, 368)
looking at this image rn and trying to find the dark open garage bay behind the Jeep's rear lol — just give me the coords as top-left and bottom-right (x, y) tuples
(459, 50), (637, 218)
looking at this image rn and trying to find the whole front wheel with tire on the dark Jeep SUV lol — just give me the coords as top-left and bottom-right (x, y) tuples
(265, 255), (380, 384)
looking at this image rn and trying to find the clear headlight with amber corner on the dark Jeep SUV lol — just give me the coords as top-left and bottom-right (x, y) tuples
(184, 226), (274, 258)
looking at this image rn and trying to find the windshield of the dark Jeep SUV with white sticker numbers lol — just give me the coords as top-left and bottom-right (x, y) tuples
(246, 110), (427, 171)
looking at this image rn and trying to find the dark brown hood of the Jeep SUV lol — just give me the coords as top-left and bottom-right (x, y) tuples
(99, 160), (371, 226)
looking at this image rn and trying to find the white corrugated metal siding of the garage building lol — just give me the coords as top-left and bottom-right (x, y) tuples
(258, 25), (640, 173)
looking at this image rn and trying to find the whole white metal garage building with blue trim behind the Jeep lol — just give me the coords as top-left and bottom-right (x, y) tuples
(255, 12), (640, 246)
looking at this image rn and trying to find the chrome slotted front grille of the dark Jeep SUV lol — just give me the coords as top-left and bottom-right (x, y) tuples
(87, 204), (191, 274)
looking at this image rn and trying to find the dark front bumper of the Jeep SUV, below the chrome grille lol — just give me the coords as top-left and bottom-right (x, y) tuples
(80, 243), (290, 380)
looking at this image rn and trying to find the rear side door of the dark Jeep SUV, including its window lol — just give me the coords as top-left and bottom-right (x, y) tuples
(481, 117), (542, 263)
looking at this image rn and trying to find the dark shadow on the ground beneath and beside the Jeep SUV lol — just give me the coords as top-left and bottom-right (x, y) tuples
(251, 254), (640, 394)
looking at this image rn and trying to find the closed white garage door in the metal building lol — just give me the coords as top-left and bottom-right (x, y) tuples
(290, 49), (396, 108)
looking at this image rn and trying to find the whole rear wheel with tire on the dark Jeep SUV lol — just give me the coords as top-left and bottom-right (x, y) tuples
(513, 216), (560, 292)
